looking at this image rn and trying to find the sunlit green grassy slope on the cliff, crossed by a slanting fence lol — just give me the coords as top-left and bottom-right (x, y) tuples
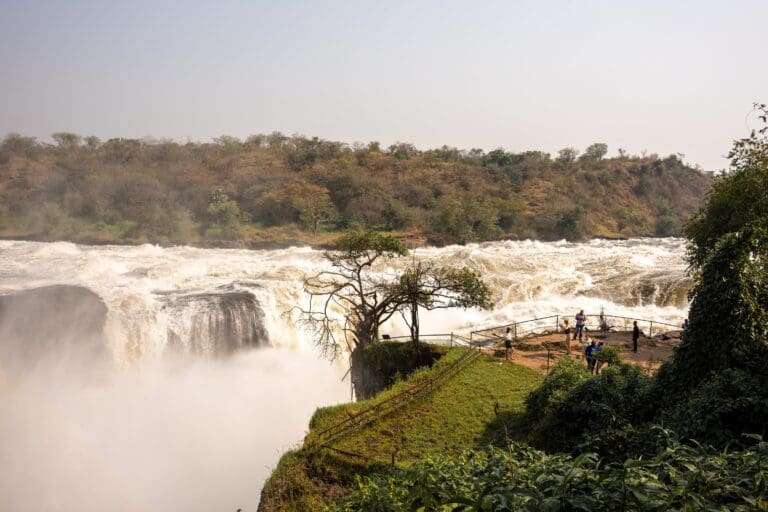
(259, 349), (543, 511)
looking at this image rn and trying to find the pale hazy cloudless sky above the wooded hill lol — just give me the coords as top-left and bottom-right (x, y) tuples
(0, 0), (768, 170)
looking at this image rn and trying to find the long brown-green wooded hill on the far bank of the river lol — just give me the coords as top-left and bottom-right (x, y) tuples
(0, 133), (711, 247)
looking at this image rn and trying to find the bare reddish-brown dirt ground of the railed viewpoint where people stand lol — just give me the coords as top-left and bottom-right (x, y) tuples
(485, 331), (680, 373)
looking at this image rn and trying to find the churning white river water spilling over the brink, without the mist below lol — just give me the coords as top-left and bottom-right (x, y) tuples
(0, 239), (691, 366)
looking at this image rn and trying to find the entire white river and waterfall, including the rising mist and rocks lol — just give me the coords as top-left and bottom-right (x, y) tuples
(0, 239), (690, 511)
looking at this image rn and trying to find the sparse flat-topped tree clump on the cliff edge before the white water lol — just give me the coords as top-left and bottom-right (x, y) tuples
(299, 231), (491, 358)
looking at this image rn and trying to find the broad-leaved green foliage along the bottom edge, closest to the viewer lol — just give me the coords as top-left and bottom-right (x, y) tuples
(338, 439), (768, 512)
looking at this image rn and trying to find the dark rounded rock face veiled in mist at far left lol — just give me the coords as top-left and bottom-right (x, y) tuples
(0, 285), (107, 371)
